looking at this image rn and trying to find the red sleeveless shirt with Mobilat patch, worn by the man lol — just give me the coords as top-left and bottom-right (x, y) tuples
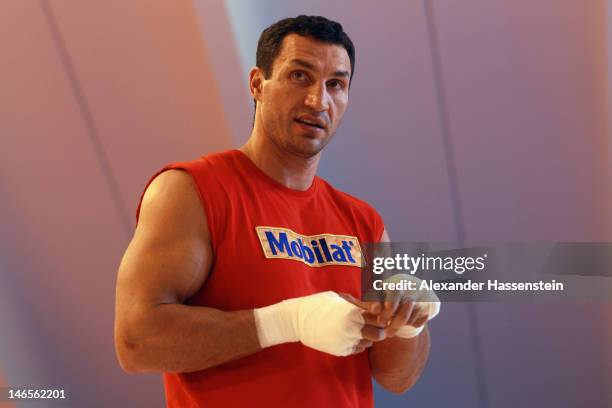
(141, 150), (384, 408)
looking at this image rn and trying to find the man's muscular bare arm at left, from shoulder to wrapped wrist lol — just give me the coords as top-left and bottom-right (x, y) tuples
(115, 170), (260, 373)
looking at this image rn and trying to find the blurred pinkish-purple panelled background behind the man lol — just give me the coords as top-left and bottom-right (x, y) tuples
(0, 0), (612, 407)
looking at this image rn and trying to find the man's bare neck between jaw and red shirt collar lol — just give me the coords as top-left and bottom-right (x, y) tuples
(240, 126), (321, 191)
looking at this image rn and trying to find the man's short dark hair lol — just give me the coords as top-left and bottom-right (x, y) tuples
(255, 15), (355, 85)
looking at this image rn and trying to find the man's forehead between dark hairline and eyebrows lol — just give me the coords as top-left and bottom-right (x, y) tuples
(274, 34), (351, 72)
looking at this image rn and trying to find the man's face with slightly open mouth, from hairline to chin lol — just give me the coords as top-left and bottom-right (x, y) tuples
(252, 34), (351, 158)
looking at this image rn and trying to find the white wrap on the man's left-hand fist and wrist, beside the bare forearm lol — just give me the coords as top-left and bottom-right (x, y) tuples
(254, 292), (364, 356)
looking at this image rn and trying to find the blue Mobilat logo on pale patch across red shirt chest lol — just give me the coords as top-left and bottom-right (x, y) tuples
(255, 227), (362, 267)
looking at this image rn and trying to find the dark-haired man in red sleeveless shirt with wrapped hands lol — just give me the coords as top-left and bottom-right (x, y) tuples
(115, 16), (431, 407)
